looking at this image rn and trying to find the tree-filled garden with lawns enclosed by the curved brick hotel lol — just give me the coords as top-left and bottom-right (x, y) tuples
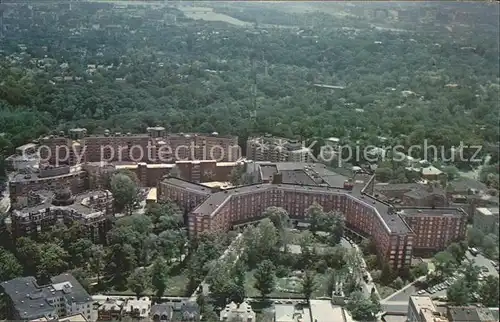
(200, 203), (380, 320)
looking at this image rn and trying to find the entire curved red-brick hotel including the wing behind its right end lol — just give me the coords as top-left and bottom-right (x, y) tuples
(158, 172), (466, 270)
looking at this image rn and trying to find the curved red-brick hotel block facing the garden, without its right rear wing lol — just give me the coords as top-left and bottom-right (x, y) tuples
(159, 178), (414, 269)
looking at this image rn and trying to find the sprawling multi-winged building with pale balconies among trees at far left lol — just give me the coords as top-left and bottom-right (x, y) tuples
(8, 188), (113, 241)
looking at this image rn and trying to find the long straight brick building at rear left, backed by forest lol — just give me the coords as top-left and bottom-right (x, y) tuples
(40, 127), (241, 165)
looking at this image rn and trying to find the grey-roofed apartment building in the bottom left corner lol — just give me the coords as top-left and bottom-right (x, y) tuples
(0, 273), (97, 322)
